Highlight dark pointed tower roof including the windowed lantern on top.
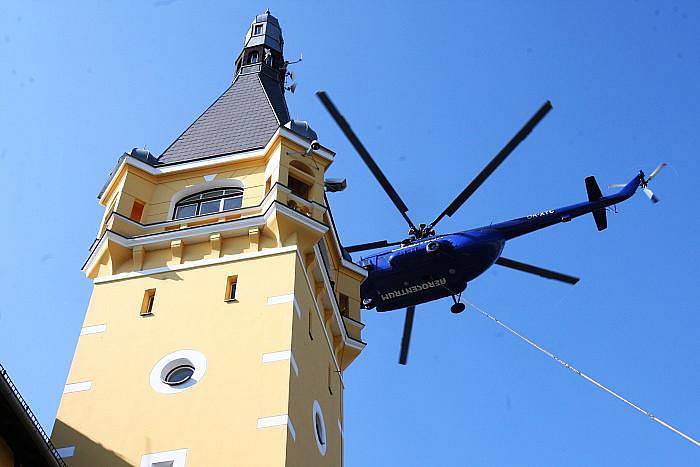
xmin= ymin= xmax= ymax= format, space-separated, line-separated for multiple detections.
xmin=158 ymin=10 xmax=290 ymax=164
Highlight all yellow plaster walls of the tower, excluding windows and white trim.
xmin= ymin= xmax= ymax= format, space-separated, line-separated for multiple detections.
xmin=59 ymin=133 xmax=362 ymax=467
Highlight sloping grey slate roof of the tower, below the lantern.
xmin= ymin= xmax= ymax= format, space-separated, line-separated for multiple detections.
xmin=158 ymin=73 xmax=290 ymax=164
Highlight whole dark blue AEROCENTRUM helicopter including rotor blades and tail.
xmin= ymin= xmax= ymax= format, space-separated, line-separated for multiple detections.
xmin=316 ymin=91 xmax=667 ymax=365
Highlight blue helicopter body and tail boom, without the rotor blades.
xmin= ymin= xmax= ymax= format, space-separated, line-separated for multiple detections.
xmin=360 ymin=174 xmax=644 ymax=311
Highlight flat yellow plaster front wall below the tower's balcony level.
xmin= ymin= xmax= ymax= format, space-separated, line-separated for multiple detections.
xmin=52 ymin=251 xmax=296 ymax=467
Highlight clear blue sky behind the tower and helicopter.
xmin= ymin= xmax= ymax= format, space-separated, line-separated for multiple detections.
xmin=0 ymin=0 xmax=700 ymax=467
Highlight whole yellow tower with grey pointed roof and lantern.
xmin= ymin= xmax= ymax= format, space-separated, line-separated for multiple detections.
xmin=52 ymin=12 xmax=366 ymax=467
